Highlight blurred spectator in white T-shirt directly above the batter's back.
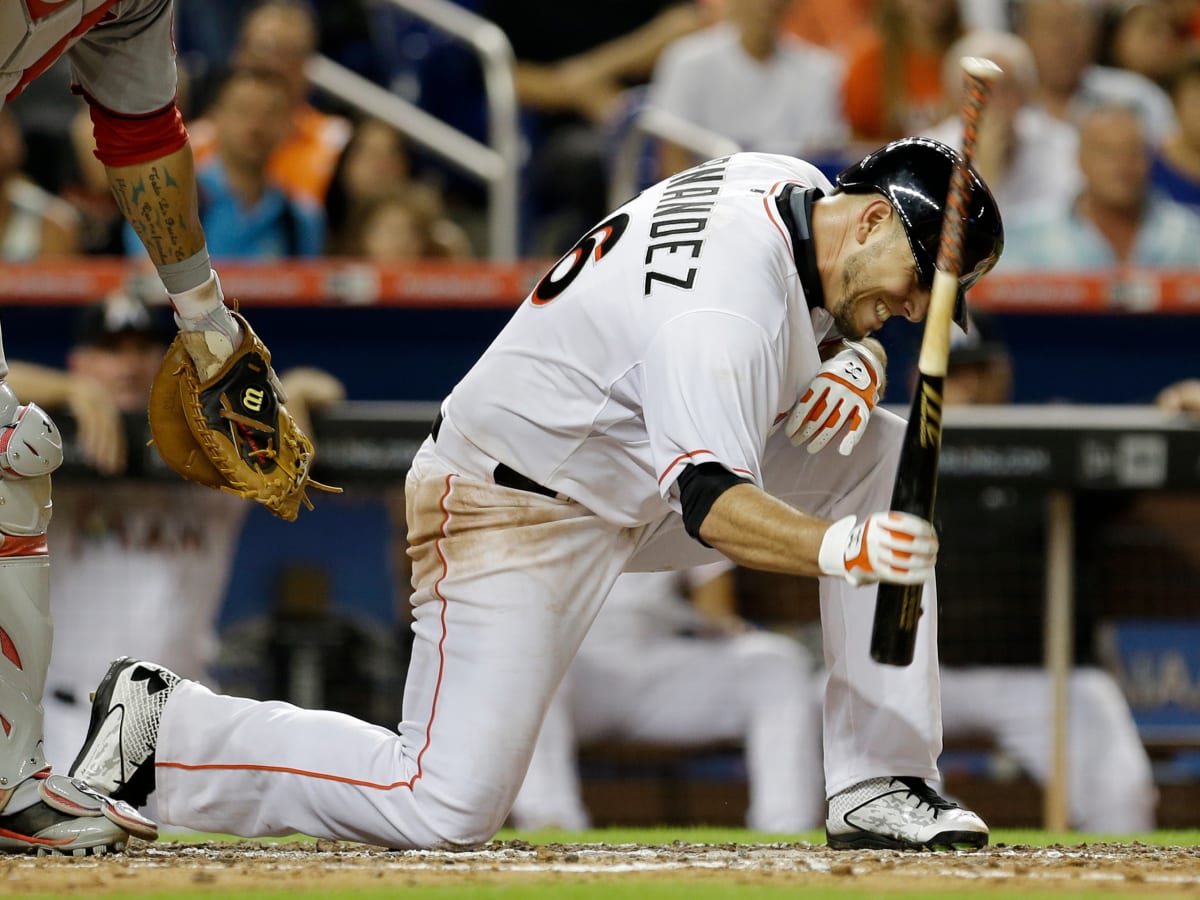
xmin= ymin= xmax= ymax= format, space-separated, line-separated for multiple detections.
xmin=647 ymin=0 xmax=848 ymax=176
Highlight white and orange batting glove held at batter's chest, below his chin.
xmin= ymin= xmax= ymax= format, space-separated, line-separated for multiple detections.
xmin=784 ymin=341 xmax=883 ymax=456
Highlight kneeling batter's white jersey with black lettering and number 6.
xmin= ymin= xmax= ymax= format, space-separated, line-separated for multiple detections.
xmin=444 ymin=154 xmax=832 ymax=526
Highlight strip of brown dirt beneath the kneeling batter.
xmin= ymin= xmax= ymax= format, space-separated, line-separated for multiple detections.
xmin=0 ymin=841 xmax=1200 ymax=895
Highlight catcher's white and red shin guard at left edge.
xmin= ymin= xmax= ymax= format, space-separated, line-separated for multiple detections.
xmin=0 ymin=383 xmax=62 ymax=810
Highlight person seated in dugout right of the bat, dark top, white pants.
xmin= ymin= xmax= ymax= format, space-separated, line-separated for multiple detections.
xmin=937 ymin=311 xmax=1157 ymax=834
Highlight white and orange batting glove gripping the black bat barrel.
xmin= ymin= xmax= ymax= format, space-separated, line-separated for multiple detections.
xmin=817 ymin=511 xmax=937 ymax=584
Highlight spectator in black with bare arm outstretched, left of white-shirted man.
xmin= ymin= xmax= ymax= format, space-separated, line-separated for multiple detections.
xmin=480 ymin=0 xmax=713 ymax=257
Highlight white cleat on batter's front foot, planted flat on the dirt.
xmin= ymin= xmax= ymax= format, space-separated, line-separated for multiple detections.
xmin=826 ymin=775 xmax=988 ymax=850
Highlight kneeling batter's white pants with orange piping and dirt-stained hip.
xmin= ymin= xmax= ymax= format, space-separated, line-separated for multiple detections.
xmin=156 ymin=410 xmax=941 ymax=847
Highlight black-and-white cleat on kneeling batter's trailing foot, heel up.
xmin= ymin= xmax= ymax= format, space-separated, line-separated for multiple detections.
xmin=71 ymin=656 xmax=180 ymax=806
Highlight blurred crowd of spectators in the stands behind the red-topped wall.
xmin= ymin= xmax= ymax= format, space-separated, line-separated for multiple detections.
xmin=11 ymin=0 xmax=1200 ymax=271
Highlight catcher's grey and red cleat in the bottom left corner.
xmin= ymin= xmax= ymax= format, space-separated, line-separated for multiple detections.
xmin=0 ymin=770 xmax=158 ymax=857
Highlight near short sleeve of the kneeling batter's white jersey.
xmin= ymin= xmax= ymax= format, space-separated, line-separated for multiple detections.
xmin=643 ymin=311 xmax=781 ymax=497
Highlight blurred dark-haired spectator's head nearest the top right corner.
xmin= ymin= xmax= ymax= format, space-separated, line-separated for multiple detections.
xmin=1097 ymin=0 xmax=1187 ymax=90
